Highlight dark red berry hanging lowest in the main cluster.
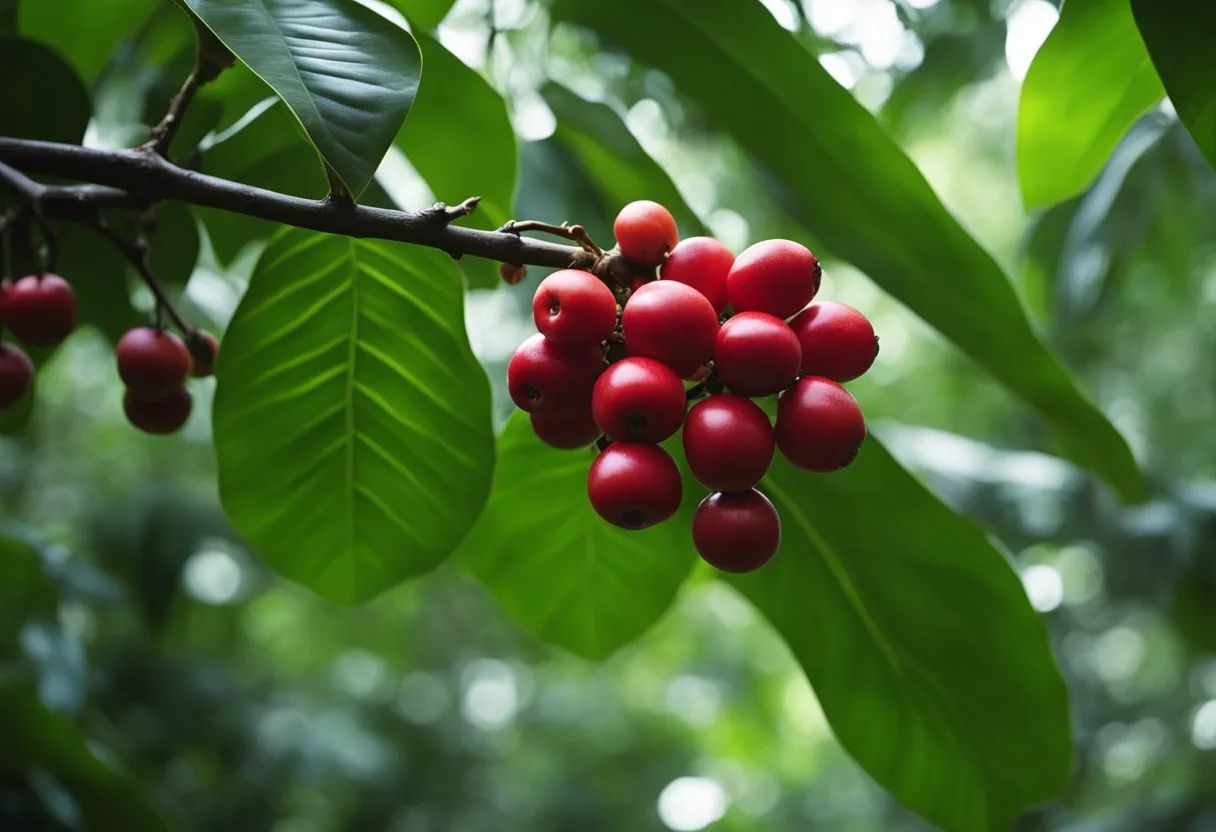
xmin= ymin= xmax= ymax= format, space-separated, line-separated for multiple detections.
xmin=692 ymin=490 xmax=781 ymax=573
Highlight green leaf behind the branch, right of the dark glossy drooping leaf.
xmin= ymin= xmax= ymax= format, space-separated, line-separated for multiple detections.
xmin=396 ymin=34 xmax=519 ymax=287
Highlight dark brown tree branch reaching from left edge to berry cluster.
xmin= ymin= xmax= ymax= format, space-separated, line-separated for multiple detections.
xmin=0 ymin=137 xmax=605 ymax=274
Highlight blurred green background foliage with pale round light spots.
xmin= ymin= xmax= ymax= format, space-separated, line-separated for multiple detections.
xmin=0 ymin=0 xmax=1216 ymax=832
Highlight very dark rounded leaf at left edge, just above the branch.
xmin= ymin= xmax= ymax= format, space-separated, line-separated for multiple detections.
xmin=0 ymin=36 xmax=92 ymax=145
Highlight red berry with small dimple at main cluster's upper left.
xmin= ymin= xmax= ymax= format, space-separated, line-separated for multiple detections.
xmin=533 ymin=269 xmax=617 ymax=347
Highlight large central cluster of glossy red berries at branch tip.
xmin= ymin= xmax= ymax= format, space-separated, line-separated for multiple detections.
xmin=507 ymin=201 xmax=878 ymax=572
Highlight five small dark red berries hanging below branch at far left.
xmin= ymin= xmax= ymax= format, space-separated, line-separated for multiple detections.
xmin=0 ymin=274 xmax=219 ymax=434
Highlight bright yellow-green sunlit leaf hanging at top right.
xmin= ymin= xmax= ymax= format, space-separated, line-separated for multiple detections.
xmin=1018 ymin=0 xmax=1165 ymax=210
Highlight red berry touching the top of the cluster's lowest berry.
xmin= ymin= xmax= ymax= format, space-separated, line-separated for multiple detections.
xmin=683 ymin=393 xmax=773 ymax=491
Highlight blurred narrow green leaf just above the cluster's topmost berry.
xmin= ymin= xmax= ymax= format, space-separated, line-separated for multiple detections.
xmin=541 ymin=83 xmax=705 ymax=237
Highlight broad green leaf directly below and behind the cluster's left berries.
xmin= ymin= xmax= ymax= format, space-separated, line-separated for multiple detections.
xmin=460 ymin=412 xmax=699 ymax=659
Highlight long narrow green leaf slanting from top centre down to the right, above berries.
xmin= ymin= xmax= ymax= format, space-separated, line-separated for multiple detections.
xmin=553 ymin=0 xmax=1143 ymax=499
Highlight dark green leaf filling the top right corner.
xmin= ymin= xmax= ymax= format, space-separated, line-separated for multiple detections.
xmin=1131 ymin=0 xmax=1216 ymax=168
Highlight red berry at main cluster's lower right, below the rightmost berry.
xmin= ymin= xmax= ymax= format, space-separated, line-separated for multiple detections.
xmin=773 ymin=376 xmax=866 ymax=472
